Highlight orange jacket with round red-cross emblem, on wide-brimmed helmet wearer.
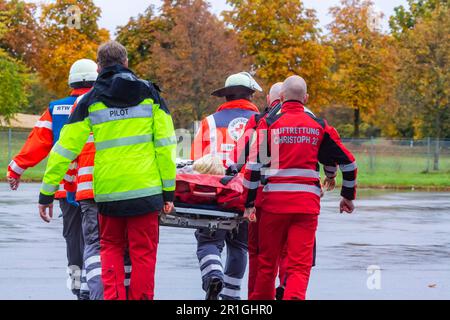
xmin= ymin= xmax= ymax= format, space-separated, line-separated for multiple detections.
xmin=191 ymin=99 xmax=259 ymax=167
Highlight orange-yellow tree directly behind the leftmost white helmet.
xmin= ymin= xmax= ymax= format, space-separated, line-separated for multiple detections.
xmin=39 ymin=0 xmax=109 ymax=96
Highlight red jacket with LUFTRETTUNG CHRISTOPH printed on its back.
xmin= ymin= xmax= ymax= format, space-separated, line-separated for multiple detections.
xmin=244 ymin=101 xmax=357 ymax=214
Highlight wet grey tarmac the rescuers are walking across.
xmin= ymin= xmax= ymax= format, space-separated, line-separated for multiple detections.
xmin=0 ymin=184 xmax=450 ymax=299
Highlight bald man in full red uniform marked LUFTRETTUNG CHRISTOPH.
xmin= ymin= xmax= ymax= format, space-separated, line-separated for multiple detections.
xmin=244 ymin=76 xmax=357 ymax=300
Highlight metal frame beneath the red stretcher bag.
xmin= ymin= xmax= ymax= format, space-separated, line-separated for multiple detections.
xmin=159 ymin=207 xmax=243 ymax=232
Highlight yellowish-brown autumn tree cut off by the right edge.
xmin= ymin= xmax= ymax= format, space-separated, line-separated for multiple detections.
xmin=397 ymin=5 xmax=450 ymax=170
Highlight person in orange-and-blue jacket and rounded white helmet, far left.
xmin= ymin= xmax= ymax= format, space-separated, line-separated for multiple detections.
xmin=7 ymin=59 xmax=97 ymax=298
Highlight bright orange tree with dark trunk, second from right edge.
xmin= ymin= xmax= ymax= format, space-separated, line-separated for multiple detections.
xmin=329 ymin=0 xmax=395 ymax=137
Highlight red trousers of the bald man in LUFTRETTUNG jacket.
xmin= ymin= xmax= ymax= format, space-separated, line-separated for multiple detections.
xmin=249 ymin=211 xmax=318 ymax=300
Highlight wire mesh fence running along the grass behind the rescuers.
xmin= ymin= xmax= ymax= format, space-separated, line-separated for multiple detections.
xmin=0 ymin=128 xmax=450 ymax=182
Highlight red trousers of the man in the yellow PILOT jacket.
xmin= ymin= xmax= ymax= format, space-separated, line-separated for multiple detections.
xmin=99 ymin=212 xmax=159 ymax=300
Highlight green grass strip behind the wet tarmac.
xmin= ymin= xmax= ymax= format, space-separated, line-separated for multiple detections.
xmin=0 ymin=131 xmax=450 ymax=190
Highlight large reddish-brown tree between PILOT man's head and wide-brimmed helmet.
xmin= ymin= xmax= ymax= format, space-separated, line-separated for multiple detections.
xmin=118 ymin=0 xmax=243 ymax=127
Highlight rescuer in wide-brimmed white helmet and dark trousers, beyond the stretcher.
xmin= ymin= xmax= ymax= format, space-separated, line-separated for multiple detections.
xmin=192 ymin=72 xmax=262 ymax=300
